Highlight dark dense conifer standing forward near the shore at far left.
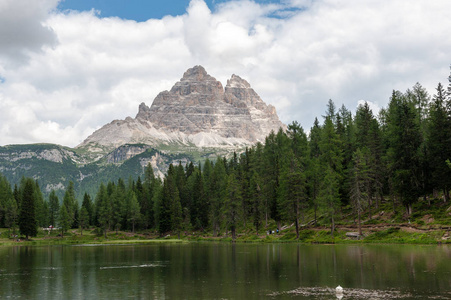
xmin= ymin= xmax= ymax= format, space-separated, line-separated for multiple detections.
xmin=19 ymin=178 xmax=38 ymax=240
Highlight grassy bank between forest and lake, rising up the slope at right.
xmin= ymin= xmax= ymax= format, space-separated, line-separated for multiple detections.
xmin=0 ymin=199 xmax=451 ymax=246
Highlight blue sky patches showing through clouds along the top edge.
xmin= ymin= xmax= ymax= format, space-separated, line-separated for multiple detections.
xmin=58 ymin=0 xmax=280 ymax=22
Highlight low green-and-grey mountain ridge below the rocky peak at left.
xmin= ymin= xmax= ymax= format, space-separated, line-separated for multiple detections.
xmin=0 ymin=144 xmax=191 ymax=199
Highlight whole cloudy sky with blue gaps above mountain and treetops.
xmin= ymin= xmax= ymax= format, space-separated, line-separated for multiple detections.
xmin=0 ymin=0 xmax=451 ymax=146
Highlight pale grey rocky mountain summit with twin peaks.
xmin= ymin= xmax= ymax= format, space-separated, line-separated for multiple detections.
xmin=77 ymin=66 xmax=285 ymax=154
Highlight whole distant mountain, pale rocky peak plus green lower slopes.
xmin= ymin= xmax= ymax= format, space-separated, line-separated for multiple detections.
xmin=0 ymin=66 xmax=286 ymax=198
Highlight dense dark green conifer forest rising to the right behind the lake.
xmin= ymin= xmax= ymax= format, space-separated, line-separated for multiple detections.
xmin=0 ymin=71 xmax=451 ymax=238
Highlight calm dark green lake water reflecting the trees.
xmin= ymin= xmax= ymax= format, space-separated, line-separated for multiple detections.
xmin=0 ymin=243 xmax=451 ymax=299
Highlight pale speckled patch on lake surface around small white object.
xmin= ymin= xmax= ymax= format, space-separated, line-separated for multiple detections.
xmin=268 ymin=287 xmax=420 ymax=300
